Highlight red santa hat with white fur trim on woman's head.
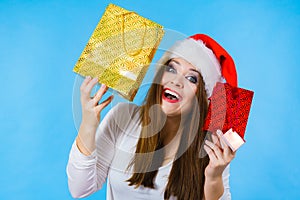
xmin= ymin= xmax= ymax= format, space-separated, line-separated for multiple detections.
xmin=158 ymin=34 xmax=237 ymax=97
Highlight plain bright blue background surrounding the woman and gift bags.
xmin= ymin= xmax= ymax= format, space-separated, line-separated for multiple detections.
xmin=0 ymin=0 xmax=300 ymax=200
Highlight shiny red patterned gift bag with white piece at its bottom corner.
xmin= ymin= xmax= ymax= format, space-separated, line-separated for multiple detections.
xmin=203 ymin=83 xmax=254 ymax=151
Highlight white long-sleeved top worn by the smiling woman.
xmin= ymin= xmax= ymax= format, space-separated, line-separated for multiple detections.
xmin=66 ymin=103 xmax=231 ymax=200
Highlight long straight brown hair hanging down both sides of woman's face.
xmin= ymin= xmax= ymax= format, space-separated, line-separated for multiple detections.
xmin=127 ymin=63 xmax=209 ymax=200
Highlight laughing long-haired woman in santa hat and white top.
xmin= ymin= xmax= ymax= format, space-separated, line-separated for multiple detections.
xmin=67 ymin=34 xmax=236 ymax=200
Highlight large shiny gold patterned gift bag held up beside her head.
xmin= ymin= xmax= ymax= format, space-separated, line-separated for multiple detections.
xmin=73 ymin=4 xmax=164 ymax=101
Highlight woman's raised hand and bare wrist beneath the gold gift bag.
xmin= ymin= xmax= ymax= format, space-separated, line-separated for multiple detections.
xmin=76 ymin=76 xmax=113 ymax=155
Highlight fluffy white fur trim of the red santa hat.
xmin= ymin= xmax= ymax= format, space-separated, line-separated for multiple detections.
xmin=158 ymin=38 xmax=222 ymax=97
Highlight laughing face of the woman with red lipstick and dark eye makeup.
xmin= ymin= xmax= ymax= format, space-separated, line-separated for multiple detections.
xmin=161 ymin=58 xmax=200 ymax=116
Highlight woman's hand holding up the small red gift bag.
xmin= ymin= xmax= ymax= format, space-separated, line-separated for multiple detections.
xmin=204 ymin=130 xmax=235 ymax=179
